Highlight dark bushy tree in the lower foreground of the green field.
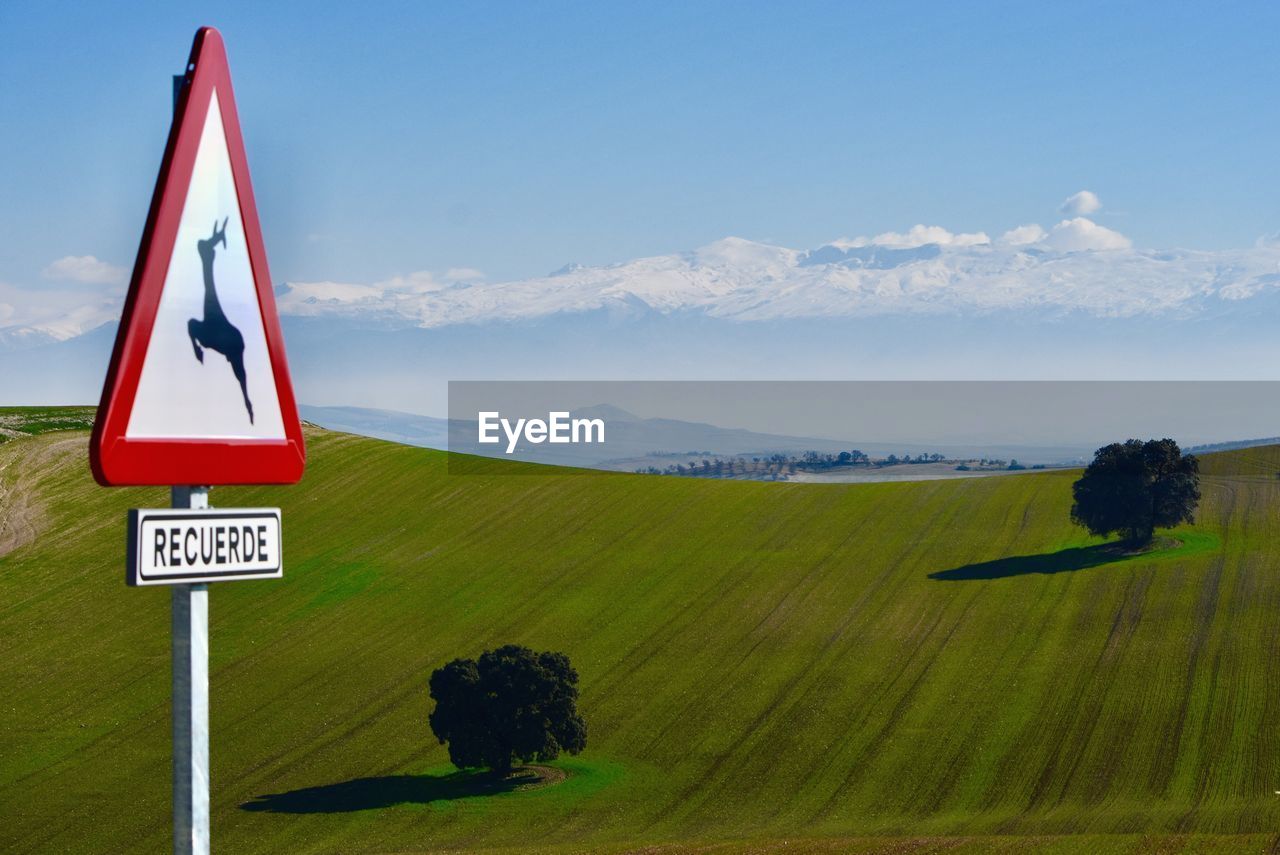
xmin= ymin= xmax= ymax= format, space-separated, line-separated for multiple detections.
xmin=430 ymin=644 xmax=586 ymax=774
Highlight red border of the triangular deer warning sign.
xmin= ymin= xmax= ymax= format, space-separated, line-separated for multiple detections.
xmin=90 ymin=27 xmax=306 ymax=486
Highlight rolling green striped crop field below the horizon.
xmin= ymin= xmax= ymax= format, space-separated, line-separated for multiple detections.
xmin=0 ymin=409 xmax=1280 ymax=852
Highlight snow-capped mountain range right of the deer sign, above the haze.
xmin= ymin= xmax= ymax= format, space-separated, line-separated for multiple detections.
xmin=280 ymin=218 xmax=1280 ymax=328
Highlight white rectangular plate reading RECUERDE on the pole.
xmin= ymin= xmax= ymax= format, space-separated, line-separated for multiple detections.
xmin=127 ymin=508 xmax=283 ymax=585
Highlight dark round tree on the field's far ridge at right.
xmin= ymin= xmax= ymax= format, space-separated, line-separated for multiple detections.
xmin=1071 ymin=439 xmax=1199 ymax=545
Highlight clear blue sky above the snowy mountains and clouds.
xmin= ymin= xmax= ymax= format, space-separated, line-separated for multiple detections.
xmin=0 ymin=3 xmax=1280 ymax=285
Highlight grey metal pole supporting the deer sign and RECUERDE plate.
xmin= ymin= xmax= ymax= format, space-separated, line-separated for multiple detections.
xmin=172 ymin=486 xmax=209 ymax=855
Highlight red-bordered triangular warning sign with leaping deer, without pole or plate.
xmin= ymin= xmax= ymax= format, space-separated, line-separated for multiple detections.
xmin=90 ymin=27 xmax=306 ymax=485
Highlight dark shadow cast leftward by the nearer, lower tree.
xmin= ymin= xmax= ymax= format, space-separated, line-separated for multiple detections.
xmin=241 ymin=769 xmax=541 ymax=814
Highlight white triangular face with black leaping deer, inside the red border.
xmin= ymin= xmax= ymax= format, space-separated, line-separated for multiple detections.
xmin=125 ymin=92 xmax=284 ymax=439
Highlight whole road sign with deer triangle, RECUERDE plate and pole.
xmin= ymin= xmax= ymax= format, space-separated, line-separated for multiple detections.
xmin=90 ymin=27 xmax=306 ymax=855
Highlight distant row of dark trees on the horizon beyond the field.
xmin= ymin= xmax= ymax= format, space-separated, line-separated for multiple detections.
xmin=636 ymin=448 xmax=1038 ymax=480
